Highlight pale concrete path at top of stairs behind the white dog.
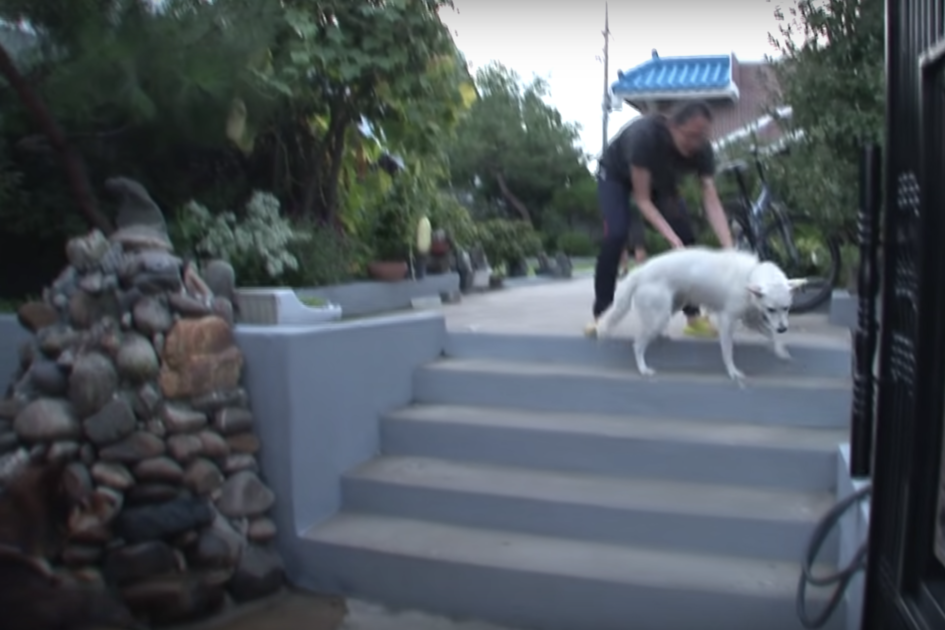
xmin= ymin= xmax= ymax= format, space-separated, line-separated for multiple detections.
xmin=443 ymin=277 xmax=850 ymax=348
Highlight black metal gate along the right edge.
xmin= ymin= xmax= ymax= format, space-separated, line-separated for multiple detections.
xmin=863 ymin=0 xmax=945 ymax=630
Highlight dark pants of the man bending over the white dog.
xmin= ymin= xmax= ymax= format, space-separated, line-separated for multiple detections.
xmin=594 ymin=176 xmax=699 ymax=318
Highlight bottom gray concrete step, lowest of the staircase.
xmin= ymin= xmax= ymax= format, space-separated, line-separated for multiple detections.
xmin=301 ymin=512 xmax=844 ymax=630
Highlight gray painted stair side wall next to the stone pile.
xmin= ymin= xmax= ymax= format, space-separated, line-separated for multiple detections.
xmin=236 ymin=312 xmax=446 ymax=581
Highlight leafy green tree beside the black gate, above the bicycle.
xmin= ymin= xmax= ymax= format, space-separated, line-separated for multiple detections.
xmin=770 ymin=0 xmax=885 ymax=228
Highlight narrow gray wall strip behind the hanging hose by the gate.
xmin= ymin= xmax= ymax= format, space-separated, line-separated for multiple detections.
xmin=837 ymin=444 xmax=870 ymax=630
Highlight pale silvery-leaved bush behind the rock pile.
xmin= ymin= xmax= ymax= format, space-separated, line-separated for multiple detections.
xmin=168 ymin=191 xmax=311 ymax=282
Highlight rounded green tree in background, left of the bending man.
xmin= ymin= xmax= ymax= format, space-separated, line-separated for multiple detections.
xmin=449 ymin=64 xmax=588 ymax=229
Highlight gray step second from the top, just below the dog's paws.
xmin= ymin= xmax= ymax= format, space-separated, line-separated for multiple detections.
xmin=414 ymin=359 xmax=851 ymax=428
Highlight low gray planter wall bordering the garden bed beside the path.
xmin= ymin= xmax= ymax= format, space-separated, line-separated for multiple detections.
xmin=295 ymin=273 xmax=459 ymax=317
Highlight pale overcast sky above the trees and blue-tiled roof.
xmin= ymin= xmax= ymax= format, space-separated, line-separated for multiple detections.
xmin=442 ymin=0 xmax=791 ymax=154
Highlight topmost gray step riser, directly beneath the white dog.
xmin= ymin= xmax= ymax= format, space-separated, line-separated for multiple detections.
xmin=445 ymin=332 xmax=851 ymax=378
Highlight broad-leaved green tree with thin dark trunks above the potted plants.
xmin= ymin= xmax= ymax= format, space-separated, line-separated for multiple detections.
xmin=253 ymin=0 xmax=467 ymax=221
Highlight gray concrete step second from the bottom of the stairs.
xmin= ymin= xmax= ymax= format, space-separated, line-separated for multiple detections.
xmin=342 ymin=457 xmax=837 ymax=562
